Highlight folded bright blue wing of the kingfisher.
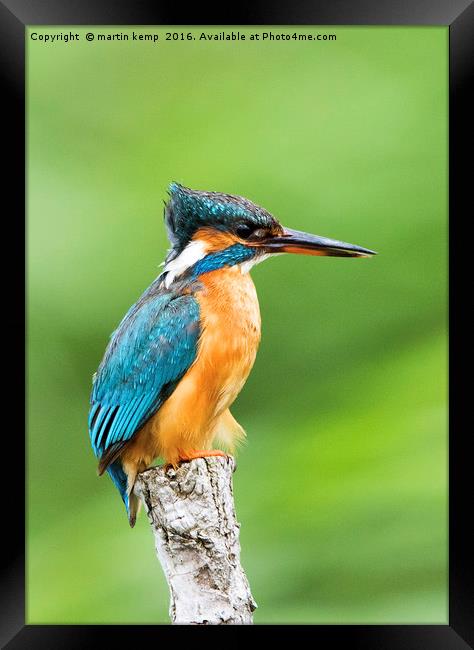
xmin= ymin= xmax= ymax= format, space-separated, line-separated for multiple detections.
xmin=89 ymin=285 xmax=200 ymax=473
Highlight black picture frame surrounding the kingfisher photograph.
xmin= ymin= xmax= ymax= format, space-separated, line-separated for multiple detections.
xmin=0 ymin=0 xmax=474 ymax=650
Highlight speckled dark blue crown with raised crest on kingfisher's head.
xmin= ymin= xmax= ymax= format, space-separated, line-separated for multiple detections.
xmin=165 ymin=183 xmax=277 ymax=250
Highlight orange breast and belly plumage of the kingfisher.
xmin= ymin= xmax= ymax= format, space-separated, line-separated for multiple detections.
xmin=124 ymin=266 xmax=260 ymax=465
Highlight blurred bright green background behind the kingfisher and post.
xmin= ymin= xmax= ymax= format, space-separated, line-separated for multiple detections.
xmin=27 ymin=27 xmax=448 ymax=623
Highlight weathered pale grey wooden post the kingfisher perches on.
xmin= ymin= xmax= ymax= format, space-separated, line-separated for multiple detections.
xmin=135 ymin=456 xmax=257 ymax=625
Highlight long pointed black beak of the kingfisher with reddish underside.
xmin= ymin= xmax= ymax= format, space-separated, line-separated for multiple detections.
xmin=261 ymin=228 xmax=377 ymax=257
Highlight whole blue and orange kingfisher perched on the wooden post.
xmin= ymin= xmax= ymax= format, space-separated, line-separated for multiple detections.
xmin=89 ymin=183 xmax=375 ymax=528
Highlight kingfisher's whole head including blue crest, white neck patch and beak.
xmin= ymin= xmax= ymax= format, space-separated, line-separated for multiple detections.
xmin=161 ymin=183 xmax=375 ymax=284
